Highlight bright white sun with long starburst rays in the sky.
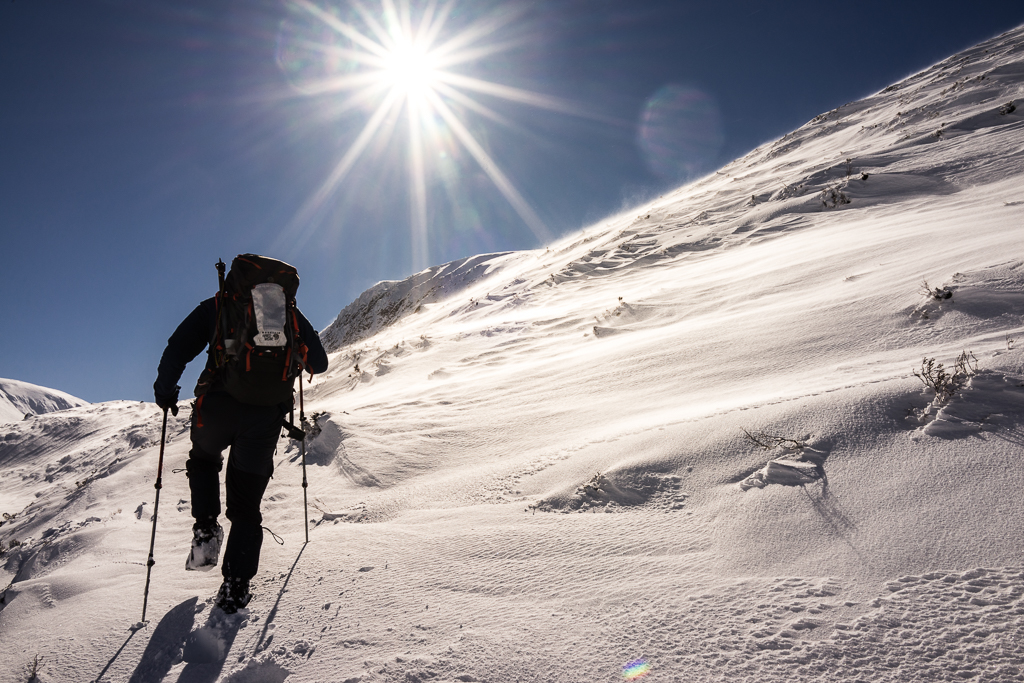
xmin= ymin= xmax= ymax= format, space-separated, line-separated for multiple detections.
xmin=275 ymin=0 xmax=591 ymax=269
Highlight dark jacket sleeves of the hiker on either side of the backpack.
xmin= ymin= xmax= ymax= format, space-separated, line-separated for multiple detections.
xmin=153 ymin=297 xmax=328 ymax=402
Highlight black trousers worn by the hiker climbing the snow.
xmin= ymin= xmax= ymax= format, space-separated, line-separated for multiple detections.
xmin=185 ymin=392 xmax=285 ymax=581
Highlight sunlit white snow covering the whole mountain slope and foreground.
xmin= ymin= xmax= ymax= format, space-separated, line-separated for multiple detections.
xmin=0 ymin=28 xmax=1024 ymax=683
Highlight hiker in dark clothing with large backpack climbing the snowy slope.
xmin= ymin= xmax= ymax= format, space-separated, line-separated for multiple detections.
xmin=154 ymin=254 xmax=328 ymax=613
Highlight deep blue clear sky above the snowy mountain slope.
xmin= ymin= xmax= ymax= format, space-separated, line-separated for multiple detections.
xmin=6 ymin=0 xmax=1024 ymax=401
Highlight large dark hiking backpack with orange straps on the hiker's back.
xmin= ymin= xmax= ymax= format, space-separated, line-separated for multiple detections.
xmin=200 ymin=254 xmax=306 ymax=405
